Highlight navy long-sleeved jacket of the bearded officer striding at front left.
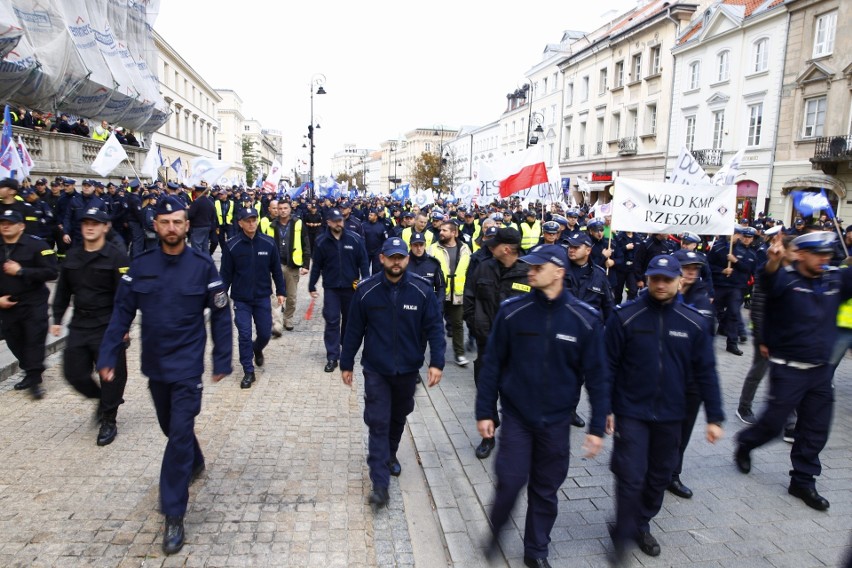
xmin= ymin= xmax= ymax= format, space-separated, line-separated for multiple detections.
xmin=98 ymin=247 xmax=233 ymax=383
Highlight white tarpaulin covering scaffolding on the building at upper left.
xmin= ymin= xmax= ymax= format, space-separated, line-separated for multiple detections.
xmin=0 ymin=0 xmax=168 ymax=132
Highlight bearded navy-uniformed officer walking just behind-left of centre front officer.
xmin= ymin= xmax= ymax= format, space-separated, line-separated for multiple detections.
xmin=308 ymin=208 xmax=370 ymax=373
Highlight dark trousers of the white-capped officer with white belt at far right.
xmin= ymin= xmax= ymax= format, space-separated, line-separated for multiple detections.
xmin=737 ymin=362 xmax=834 ymax=488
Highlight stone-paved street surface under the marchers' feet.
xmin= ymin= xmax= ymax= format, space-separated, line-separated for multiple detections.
xmin=0 ymin=272 xmax=852 ymax=568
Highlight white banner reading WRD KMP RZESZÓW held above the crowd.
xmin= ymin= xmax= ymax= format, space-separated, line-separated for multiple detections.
xmin=612 ymin=177 xmax=737 ymax=235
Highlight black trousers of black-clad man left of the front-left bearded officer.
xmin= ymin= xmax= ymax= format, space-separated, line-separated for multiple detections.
xmin=62 ymin=327 xmax=127 ymax=414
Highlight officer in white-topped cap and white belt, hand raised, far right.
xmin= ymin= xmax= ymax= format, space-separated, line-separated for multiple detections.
xmin=735 ymin=231 xmax=852 ymax=511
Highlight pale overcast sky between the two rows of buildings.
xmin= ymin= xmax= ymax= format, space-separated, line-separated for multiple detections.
xmin=154 ymin=0 xmax=636 ymax=175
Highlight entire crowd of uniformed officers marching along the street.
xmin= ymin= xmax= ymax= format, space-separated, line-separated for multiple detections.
xmin=0 ymin=178 xmax=852 ymax=566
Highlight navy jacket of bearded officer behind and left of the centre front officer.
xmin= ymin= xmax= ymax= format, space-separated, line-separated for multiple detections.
xmin=308 ymin=229 xmax=370 ymax=292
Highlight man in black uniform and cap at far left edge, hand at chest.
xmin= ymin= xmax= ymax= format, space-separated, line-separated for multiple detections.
xmin=0 ymin=209 xmax=57 ymax=399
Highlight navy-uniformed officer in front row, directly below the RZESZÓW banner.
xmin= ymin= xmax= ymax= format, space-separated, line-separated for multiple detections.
xmin=605 ymin=255 xmax=725 ymax=564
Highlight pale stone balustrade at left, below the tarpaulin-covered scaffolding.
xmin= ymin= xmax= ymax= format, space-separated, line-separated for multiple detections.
xmin=12 ymin=126 xmax=148 ymax=179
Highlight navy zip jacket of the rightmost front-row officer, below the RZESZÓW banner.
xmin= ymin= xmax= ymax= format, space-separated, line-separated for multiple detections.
xmin=606 ymin=293 xmax=725 ymax=423
